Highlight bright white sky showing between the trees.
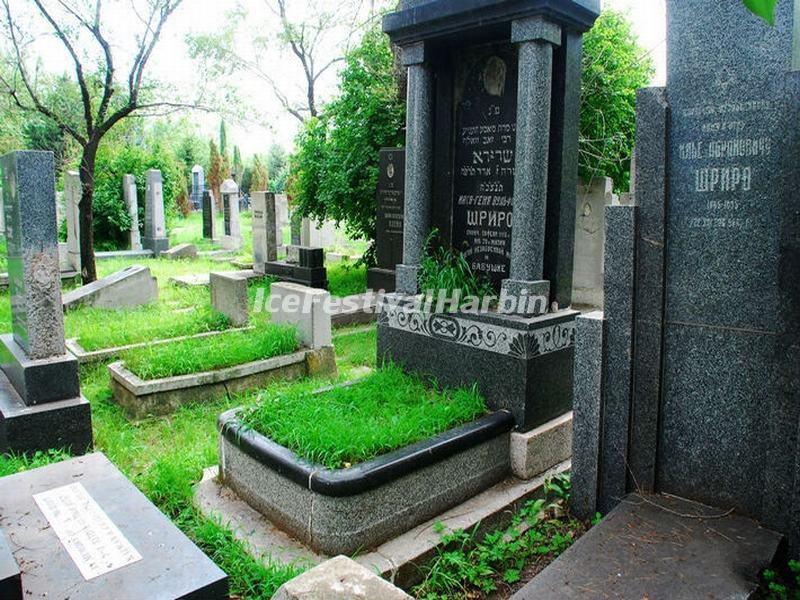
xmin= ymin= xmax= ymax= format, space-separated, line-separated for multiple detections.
xmin=25 ymin=0 xmax=666 ymax=155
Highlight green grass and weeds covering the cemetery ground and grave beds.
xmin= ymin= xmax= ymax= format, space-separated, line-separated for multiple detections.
xmin=0 ymin=235 xmax=583 ymax=598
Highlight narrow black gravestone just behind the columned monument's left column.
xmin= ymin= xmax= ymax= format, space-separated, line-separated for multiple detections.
xmin=367 ymin=148 xmax=406 ymax=292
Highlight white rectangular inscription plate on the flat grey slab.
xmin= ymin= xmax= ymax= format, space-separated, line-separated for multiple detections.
xmin=33 ymin=483 xmax=142 ymax=581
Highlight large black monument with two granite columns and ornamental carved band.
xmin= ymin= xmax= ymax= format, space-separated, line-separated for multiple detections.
xmin=378 ymin=0 xmax=600 ymax=431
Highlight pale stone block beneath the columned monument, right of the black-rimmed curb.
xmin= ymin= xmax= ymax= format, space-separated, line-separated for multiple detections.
xmin=511 ymin=412 xmax=572 ymax=479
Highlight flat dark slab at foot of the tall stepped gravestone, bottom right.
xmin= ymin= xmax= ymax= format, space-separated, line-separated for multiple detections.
xmin=512 ymin=494 xmax=781 ymax=600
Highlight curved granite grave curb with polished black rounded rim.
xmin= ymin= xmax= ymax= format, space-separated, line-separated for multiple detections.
xmin=218 ymin=384 xmax=514 ymax=555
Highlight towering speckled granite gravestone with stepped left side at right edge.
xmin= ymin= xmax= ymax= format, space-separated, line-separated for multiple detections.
xmin=573 ymin=0 xmax=800 ymax=554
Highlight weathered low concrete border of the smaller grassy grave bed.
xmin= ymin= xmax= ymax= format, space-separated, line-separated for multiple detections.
xmin=108 ymin=346 xmax=336 ymax=419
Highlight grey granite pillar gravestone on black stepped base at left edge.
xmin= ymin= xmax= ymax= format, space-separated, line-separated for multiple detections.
xmin=0 ymin=152 xmax=92 ymax=454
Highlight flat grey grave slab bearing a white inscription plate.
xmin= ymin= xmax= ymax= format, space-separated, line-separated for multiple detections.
xmin=0 ymin=454 xmax=229 ymax=600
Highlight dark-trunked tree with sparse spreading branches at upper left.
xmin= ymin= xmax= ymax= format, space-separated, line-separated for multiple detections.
xmin=0 ymin=0 xmax=192 ymax=283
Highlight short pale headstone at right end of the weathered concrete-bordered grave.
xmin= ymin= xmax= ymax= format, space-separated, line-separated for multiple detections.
xmin=270 ymin=282 xmax=333 ymax=348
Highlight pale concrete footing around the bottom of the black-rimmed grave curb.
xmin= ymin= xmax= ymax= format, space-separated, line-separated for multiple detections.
xmin=194 ymin=462 xmax=570 ymax=589
